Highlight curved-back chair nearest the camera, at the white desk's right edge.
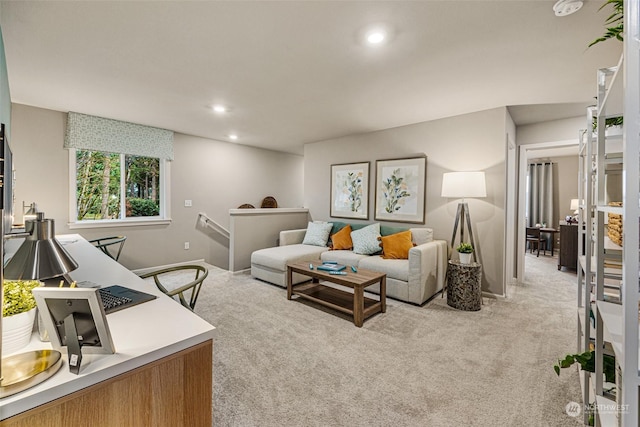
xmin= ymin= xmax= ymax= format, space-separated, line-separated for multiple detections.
xmin=140 ymin=265 xmax=209 ymax=311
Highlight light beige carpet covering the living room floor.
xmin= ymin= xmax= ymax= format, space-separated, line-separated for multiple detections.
xmin=180 ymin=256 xmax=581 ymax=426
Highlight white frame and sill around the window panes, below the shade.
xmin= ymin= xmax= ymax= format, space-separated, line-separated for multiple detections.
xmin=68 ymin=148 xmax=171 ymax=229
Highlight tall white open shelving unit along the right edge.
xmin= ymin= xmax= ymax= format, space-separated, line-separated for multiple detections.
xmin=578 ymin=1 xmax=640 ymax=426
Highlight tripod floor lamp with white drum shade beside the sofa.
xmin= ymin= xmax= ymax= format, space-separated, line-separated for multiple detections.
xmin=441 ymin=172 xmax=487 ymax=261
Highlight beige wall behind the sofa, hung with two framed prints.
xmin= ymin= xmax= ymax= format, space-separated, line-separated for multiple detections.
xmin=304 ymin=108 xmax=508 ymax=295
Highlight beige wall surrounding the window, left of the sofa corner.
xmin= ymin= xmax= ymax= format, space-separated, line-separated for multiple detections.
xmin=12 ymin=104 xmax=304 ymax=269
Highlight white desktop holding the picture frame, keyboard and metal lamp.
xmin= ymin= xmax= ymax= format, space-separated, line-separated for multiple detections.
xmin=0 ymin=234 xmax=215 ymax=420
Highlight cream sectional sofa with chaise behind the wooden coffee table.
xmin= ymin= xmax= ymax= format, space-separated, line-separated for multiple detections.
xmin=251 ymin=222 xmax=448 ymax=304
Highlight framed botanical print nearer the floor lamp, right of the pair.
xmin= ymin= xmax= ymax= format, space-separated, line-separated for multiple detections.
xmin=375 ymin=156 xmax=427 ymax=224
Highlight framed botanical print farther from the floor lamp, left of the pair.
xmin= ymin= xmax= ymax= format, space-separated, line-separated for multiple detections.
xmin=329 ymin=162 xmax=369 ymax=219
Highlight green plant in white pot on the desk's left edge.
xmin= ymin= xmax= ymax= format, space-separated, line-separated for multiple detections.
xmin=2 ymin=280 xmax=41 ymax=354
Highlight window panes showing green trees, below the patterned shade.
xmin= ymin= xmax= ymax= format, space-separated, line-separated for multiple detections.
xmin=70 ymin=149 xmax=167 ymax=223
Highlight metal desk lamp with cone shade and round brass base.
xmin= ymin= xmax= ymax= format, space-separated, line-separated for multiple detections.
xmin=0 ymin=211 xmax=78 ymax=398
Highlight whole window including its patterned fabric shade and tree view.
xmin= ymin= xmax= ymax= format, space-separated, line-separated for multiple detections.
xmin=64 ymin=111 xmax=173 ymax=228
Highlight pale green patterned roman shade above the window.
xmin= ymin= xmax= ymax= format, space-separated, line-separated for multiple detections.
xmin=64 ymin=112 xmax=173 ymax=160
